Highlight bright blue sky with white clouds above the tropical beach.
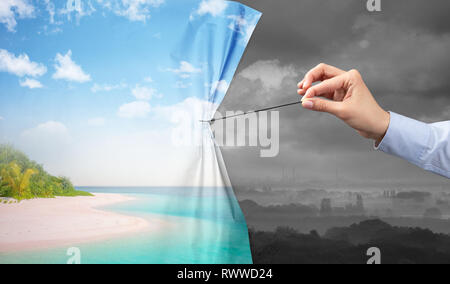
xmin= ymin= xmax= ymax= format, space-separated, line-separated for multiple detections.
xmin=0 ymin=0 xmax=260 ymax=186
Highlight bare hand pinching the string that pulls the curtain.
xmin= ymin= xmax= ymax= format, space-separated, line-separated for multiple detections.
xmin=298 ymin=64 xmax=390 ymax=145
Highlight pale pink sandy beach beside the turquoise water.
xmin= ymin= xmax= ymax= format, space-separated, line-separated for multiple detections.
xmin=0 ymin=194 xmax=155 ymax=253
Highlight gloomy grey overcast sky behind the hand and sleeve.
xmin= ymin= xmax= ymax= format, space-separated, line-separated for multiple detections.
xmin=220 ymin=0 xmax=450 ymax=190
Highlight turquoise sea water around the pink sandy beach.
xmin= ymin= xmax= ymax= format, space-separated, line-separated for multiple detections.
xmin=0 ymin=187 xmax=252 ymax=264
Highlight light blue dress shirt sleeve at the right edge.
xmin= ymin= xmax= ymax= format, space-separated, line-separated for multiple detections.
xmin=377 ymin=112 xmax=450 ymax=178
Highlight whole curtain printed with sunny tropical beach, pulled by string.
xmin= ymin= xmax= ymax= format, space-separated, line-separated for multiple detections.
xmin=0 ymin=0 xmax=261 ymax=263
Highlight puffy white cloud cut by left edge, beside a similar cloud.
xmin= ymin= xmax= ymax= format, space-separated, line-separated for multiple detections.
xmin=0 ymin=49 xmax=47 ymax=77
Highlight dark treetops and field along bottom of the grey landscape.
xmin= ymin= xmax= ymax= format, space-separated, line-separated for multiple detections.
xmin=250 ymin=220 xmax=450 ymax=264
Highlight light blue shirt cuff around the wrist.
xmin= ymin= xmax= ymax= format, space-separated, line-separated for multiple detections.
xmin=375 ymin=112 xmax=431 ymax=166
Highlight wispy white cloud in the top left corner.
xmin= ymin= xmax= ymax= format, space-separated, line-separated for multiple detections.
xmin=0 ymin=0 xmax=34 ymax=32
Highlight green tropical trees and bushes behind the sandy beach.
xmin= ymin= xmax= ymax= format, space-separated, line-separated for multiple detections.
xmin=0 ymin=144 xmax=91 ymax=200
